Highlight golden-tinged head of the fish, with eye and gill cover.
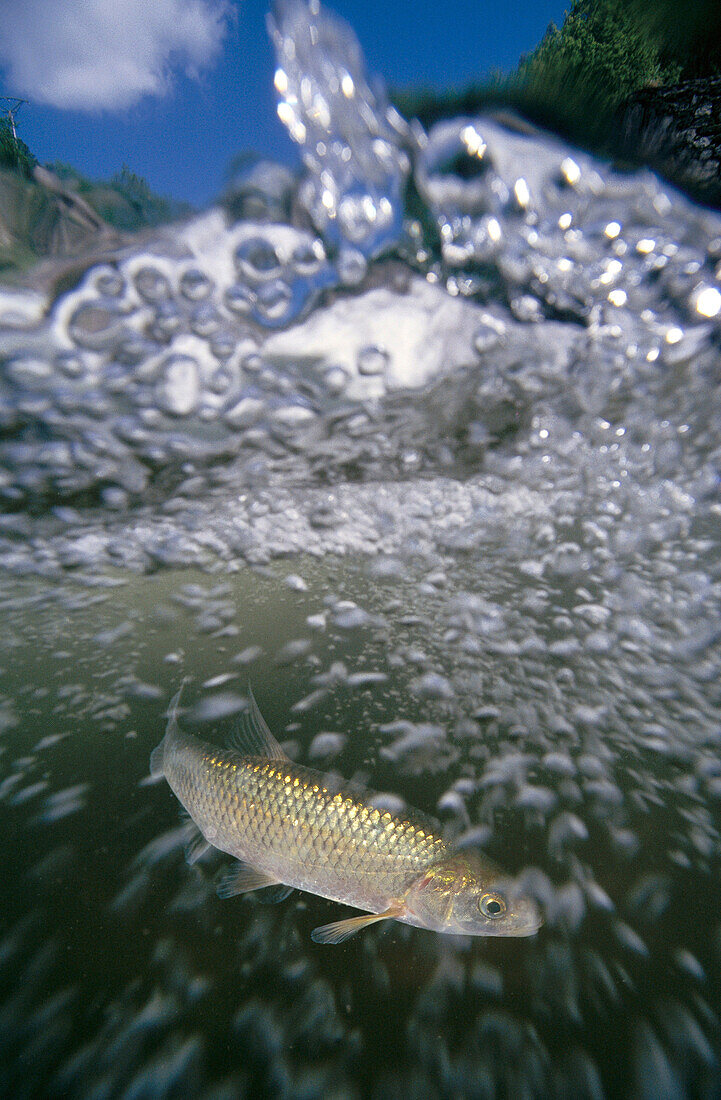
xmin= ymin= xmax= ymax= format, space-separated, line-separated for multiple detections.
xmin=403 ymin=851 xmax=543 ymax=936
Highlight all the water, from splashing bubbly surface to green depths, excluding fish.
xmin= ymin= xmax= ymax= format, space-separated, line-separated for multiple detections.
xmin=0 ymin=4 xmax=721 ymax=1098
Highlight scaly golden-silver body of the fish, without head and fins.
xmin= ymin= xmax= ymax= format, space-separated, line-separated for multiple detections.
xmin=169 ymin=734 xmax=448 ymax=909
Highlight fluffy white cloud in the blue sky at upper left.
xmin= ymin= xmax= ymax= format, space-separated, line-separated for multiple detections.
xmin=0 ymin=0 xmax=233 ymax=110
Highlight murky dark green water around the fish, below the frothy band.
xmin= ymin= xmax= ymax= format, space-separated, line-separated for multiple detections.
xmin=0 ymin=559 xmax=721 ymax=1097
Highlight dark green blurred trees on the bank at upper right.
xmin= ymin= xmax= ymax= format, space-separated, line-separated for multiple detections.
xmin=393 ymin=0 xmax=721 ymax=150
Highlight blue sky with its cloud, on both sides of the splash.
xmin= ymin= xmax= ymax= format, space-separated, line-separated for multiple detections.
xmin=0 ymin=0 xmax=570 ymax=206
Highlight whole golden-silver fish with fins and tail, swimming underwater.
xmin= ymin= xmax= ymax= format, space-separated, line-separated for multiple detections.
xmin=150 ymin=686 xmax=543 ymax=944
